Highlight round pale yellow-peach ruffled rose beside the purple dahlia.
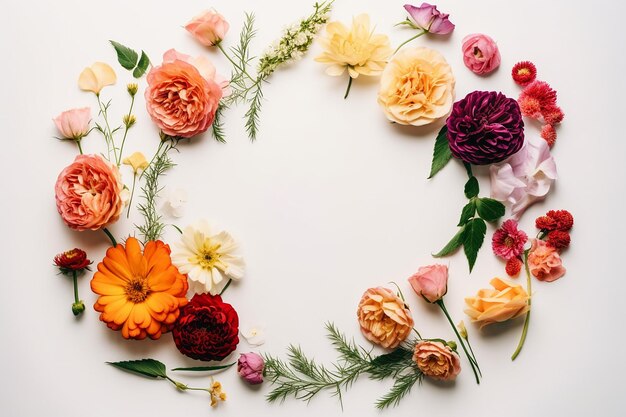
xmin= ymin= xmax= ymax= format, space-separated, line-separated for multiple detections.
xmin=378 ymin=47 xmax=455 ymax=126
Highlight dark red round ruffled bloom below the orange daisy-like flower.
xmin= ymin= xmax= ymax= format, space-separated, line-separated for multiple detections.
xmin=172 ymin=294 xmax=239 ymax=361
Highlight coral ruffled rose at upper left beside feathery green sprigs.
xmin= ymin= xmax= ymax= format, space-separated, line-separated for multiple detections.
xmin=145 ymin=49 xmax=226 ymax=138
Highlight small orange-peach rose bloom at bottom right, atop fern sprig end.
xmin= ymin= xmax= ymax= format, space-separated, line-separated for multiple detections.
xmin=413 ymin=340 xmax=461 ymax=381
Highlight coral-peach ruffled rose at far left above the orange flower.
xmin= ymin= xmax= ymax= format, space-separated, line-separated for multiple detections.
xmin=54 ymin=155 xmax=124 ymax=231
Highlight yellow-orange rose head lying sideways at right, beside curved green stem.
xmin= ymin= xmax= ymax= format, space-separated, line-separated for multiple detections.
xmin=465 ymin=278 xmax=529 ymax=328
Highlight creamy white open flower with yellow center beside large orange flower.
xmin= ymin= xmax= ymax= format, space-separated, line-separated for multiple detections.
xmin=172 ymin=220 xmax=245 ymax=295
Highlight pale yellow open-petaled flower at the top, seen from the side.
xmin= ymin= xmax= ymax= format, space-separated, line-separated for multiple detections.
xmin=315 ymin=14 xmax=392 ymax=78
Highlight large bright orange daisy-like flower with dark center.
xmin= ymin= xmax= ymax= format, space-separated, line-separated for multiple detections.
xmin=91 ymin=237 xmax=188 ymax=339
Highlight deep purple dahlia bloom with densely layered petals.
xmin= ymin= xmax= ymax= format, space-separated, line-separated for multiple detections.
xmin=446 ymin=91 xmax=524 ymax=165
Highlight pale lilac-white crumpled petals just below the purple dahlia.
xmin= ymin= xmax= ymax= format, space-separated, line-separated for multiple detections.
xmin=489 ymin=137 xmax=557 ymax=220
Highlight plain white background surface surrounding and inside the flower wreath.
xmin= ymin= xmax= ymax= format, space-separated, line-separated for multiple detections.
xmin=0 ymin=0 xmax=626 ymax=417
